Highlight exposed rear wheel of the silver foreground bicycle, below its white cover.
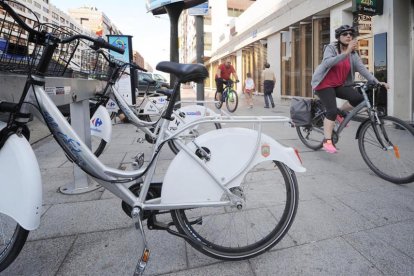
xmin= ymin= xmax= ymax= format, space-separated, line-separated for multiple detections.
xmin=171 ymin=161 xmax=299 ymax=261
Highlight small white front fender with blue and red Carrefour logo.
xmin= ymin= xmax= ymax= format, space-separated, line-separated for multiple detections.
xmin=90 ymin=105 xmax=112 ymax=143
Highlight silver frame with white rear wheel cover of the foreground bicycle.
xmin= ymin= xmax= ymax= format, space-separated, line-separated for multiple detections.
xmin=1 ymin=80 xmax=305 ymax=224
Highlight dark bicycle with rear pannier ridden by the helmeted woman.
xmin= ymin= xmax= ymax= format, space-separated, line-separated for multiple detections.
xmin=296 ymin=83 xmax=414 ymax=184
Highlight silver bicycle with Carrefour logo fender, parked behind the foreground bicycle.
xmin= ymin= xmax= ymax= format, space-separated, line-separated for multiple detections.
xmin=83 ymin=51 xmax=221 ymax=156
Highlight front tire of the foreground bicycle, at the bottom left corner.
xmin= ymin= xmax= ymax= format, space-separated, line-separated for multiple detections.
xmin=0 ymin=214 xmax=29 ymax=272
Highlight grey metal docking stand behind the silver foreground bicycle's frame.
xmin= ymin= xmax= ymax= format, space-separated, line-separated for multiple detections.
xmin=0 ymin=74 xmax=105 ymax=195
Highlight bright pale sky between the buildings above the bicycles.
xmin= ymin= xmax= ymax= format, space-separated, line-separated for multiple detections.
xmin=49 ymin=0 xmax=170 ymax=69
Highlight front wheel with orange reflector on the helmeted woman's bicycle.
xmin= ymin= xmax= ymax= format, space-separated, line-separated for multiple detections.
xmin=358 ymin=116 xmax=414 ymax=184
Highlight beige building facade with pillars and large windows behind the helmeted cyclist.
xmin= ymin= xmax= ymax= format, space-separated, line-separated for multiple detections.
xmin=180 ymin=0 xmax=414 ymax=120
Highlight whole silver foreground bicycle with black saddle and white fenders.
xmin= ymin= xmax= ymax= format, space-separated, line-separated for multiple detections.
xmin=0 ymin=0 xmax=305 ymax=275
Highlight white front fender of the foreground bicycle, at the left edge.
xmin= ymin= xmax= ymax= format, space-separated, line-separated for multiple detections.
xmin=0 ymin=134 xmax=42 ymax=231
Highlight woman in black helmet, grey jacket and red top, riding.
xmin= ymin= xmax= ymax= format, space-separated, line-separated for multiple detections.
xmin=311 ymin=25 xmax=388 ymax=153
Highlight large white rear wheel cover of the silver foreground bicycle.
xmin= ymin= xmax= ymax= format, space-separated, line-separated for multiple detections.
xmin=161 ymin=128 xmax=306 ymax=204
